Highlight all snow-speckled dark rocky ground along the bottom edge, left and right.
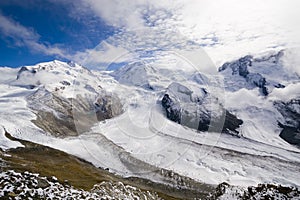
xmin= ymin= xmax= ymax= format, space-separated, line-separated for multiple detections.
xmin=0 ymin=170 xmax=300 ymax=200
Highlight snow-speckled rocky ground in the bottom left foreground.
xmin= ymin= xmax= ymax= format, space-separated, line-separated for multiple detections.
xmin=0 ymin=170 xmax=161 ymax=200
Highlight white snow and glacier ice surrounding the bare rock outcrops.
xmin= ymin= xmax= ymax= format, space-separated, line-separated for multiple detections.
xmin=0 ymin=50 xmax=300 ymax=191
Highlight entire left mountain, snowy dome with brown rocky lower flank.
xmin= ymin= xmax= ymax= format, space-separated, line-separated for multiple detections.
xmin=0 ymin=60 xmax=122 ymax=137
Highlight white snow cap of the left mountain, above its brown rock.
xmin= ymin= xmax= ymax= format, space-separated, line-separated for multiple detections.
xmin=10 ymin=60 xmax=101 ymax=98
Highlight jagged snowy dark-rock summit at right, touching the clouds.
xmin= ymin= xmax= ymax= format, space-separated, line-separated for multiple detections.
xmin=219 ymin=51 xmax=299 ymax=96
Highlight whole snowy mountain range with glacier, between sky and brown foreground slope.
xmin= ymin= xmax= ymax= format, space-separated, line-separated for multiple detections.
xmin=0 ymin=51 xmax=300 ymax=198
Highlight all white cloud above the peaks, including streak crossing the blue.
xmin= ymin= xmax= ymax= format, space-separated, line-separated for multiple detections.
xmin=0 ymin=0 xmax=300 ymax=70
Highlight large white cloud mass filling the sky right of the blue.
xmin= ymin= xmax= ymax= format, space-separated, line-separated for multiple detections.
xmin=75 ymin=0 xmax=300 ymax=68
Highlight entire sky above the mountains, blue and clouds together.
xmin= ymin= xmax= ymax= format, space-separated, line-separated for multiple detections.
xmin=0 ymin=0 xmax=300 ymax=69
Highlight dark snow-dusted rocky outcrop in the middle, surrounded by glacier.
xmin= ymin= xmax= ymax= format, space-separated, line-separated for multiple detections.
xmin=161 ymin=83 xmax=243 ymax=135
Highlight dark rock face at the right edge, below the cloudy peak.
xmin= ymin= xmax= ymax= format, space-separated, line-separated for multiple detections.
xmin=274 ymin=99 xmax=300 ymax=146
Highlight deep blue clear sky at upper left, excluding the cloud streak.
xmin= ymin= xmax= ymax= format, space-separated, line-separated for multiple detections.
xmin=0 ymin=0 xmax=114 ymax=67
